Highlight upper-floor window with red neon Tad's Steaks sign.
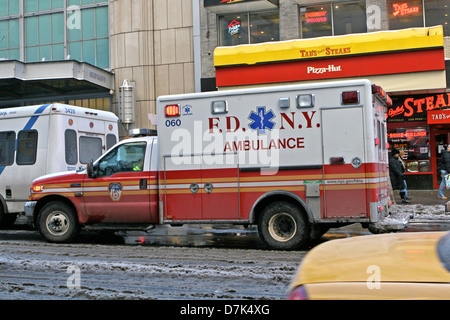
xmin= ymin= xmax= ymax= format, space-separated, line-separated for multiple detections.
xmin=387 ymin=0 xmax=423 ymax=30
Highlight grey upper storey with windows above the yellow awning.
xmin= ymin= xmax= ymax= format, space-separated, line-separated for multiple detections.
xmin=200 ymin=0 xmax=450 ymax=80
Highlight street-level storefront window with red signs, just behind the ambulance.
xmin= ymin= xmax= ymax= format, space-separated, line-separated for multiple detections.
xmin=388 ymin=127 xmax=431 ymax=172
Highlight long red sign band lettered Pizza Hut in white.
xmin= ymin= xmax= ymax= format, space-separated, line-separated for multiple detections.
xmin=216 ymin=48 xmax=445 ymax=87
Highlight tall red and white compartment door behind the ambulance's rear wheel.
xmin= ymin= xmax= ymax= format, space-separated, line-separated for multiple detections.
xmin=321 ymin=106 xmax=367 ymax=219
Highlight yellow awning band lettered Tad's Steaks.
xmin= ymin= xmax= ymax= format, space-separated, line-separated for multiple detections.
xmin=214 ymin=26 xmax=444 ymax=67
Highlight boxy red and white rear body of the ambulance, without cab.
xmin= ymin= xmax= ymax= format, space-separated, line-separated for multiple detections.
xmin=158 ymin=80 xmax=387 ymax=223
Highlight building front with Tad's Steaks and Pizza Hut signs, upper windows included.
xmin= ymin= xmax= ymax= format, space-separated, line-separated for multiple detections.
xmin=201 ymin=0 xmax=450 ymax=189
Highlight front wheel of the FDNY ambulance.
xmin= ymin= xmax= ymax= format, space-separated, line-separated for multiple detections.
xmin=37 ymin=201 xmax=80 ymax=243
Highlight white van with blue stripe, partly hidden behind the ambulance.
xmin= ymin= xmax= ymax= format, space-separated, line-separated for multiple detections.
xmin=0 ymin=103 xmax=118 ymax=226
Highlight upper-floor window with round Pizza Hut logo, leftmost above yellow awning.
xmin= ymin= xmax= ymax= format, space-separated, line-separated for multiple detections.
xmin=219 ymin=10 xmax=280 ymax=46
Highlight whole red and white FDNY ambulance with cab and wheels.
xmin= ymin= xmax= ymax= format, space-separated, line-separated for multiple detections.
xmin=26 ymin=80 xmax=407 ymax=249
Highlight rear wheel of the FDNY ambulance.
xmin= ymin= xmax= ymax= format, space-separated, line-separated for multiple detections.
xmin=258 ymin=201 xmax=309 ymax=250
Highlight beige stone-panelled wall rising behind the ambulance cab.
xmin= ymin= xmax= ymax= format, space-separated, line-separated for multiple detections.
xmin=110 ymin=0 xmax=194 ymax=128
